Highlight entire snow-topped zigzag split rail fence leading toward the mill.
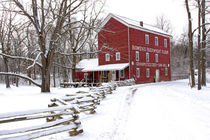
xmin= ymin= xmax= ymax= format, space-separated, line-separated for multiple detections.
xmin=0 ymin=79 xmax=135 ymax=140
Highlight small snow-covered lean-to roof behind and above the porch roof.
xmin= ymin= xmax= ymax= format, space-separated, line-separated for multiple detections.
xmin=76 ymin=58 xmax=98 ymax=69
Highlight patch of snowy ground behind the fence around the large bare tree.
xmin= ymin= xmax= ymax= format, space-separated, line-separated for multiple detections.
xmin=0 ymin=84 xmax=89 ymax=113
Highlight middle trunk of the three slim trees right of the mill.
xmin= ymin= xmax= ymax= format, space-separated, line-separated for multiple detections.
xmin=197 ymin=0 xmax=201 ymax=90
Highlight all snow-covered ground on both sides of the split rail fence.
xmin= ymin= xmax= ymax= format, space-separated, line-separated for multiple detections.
xmin=0 ymin=80 xmax=210 ymax=140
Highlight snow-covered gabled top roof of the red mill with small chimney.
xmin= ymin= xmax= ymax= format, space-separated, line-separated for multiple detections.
xmin=101 ymin=13 xmax=171 ymax=37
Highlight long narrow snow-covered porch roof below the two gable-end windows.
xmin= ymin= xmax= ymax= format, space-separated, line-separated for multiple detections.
xmin=82 ymin=63 xmax=129 ymax=72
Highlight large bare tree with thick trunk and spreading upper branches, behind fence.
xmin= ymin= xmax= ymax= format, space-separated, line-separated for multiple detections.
xmin=0 ymin=0 xmax=85 ymax=92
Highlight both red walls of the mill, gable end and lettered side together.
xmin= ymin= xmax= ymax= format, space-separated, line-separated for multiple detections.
xmin=76 ymin=18 xmax=171 ymax=83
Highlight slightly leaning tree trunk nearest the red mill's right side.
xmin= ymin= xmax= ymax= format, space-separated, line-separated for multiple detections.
xmin=185 ymin=0 xmax=195 ymax=88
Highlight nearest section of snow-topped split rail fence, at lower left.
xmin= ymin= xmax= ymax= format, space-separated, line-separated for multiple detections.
xmin=0 ymin=105 xmax=83 ymax=140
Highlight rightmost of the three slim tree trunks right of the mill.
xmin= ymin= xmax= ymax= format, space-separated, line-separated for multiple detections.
xmin=201 ymin=0 xmax=206 ymax=86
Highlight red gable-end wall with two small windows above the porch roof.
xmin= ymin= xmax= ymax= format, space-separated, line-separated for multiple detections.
xmin=98 ymin=18 xmax=129 ymax=65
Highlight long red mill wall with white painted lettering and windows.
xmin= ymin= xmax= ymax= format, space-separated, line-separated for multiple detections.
xmin=129 ymin=28 xmax=171 ymax=83
